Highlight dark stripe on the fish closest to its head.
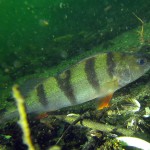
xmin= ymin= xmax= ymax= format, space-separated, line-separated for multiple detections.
xmin=107 ymin=52 xmax=116 ymax=77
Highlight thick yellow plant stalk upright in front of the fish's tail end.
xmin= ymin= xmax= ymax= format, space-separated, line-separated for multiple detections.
xmin=12 ymin=85 xmax=35 ymax=150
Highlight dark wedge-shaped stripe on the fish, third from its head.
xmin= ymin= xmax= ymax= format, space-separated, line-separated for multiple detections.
xmin=55 ymin=70 xmax=76 ymax=104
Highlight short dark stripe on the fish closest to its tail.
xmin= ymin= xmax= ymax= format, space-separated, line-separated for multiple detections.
xmin=36 ymin=84 xmax=48 ymax=107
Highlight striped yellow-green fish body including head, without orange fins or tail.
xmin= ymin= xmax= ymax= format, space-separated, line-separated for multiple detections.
xmin=25 ymin=52 xmax=150 ymax=112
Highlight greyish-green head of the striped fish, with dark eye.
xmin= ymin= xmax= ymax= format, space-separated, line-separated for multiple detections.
xmin=115 ymin=53 xmax=150 ymax=87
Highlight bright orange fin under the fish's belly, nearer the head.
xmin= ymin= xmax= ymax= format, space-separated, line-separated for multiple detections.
xmin=98 ymin=93 xmax=113 ymax=110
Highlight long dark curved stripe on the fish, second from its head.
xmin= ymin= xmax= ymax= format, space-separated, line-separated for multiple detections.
xmin=85 ymin=57 xmax=100 ymax=91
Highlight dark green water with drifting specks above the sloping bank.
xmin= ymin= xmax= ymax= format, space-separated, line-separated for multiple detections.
xmin=0 ymin=0 xmax=150 ymax=87
